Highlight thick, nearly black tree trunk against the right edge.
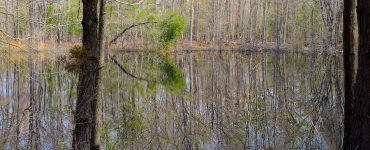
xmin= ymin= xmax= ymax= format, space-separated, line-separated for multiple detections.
xmin=344 ymin=0 xmax=370 ymax=150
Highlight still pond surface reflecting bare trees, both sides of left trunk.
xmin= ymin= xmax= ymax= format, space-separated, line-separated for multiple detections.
xmin=0 ymin=52 xmax=343 ymax=149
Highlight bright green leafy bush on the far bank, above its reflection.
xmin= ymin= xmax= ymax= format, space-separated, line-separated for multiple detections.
xmin=160 ymin=14 xmax=186 ymax=49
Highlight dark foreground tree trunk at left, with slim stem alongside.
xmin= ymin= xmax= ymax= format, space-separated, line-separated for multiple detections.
xmin=73 ymin=0 xmax=104 ymax=149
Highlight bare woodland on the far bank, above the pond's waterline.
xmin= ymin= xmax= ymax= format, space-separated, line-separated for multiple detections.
xmin=0 ymin=0 xmax=343 ymax=50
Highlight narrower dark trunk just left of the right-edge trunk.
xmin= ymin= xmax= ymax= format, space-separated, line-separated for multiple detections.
xmin=343 ymin=0 xmax=356 ymax=146
